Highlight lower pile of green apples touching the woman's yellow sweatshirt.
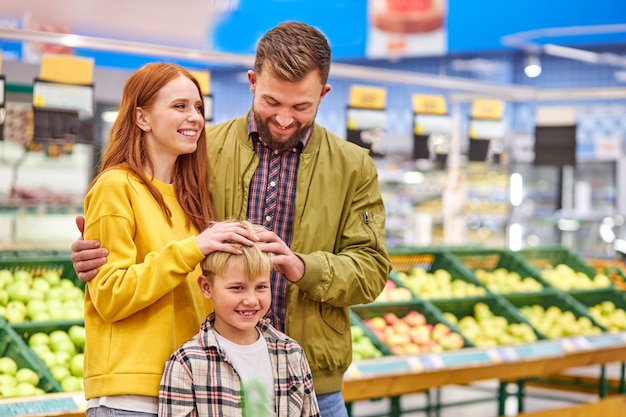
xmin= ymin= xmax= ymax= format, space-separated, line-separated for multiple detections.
xmin=24 ymin=325 xmax=85 ymax=392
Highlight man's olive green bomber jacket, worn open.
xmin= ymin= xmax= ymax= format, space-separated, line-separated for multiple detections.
xmin=207 ymin=116 xmax=391 ymax=394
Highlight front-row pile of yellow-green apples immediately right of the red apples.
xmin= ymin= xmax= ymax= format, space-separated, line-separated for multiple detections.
xmin=443 ymin=302 xmax=537 ymax=348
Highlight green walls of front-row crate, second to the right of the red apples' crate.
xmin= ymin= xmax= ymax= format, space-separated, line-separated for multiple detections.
xmin=503 ymin=289 xmax=607 ymax=337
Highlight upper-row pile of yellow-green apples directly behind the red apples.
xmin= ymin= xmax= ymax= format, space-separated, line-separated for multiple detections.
xmin=398 ymin=267 xmax=487 ymax=300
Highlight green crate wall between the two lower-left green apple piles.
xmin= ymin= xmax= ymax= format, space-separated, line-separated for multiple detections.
xmin=0 ymin=326 xmax=63 ymax=393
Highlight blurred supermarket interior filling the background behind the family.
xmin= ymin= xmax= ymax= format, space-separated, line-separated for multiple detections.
xmin=0 ymin=0 xmax=626 ymax=417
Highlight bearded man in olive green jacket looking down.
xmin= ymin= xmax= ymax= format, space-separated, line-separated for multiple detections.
xmin=72 ymin=22 xmax=391 ymax=417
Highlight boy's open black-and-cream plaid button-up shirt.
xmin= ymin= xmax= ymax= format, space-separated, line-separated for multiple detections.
xmin=159 ymin=313 xmax=319 ymax=417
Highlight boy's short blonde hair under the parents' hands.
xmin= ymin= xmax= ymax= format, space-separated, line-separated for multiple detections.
xmin=200 ymin=220 xmax=273 ymax=281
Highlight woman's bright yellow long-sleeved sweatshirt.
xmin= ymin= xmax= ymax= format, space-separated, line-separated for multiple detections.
xmin=84 ymin=169 xmax=212 ymax=399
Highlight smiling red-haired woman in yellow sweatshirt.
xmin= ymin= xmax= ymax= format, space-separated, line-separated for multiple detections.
xmin=84 ymin=63 xmax=254 ymax=417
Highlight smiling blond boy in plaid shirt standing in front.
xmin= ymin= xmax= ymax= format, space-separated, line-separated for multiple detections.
xmin=159 ymin=222 xmax=319 ymax=417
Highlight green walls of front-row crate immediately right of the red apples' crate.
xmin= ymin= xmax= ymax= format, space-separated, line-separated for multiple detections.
xmin=432 ymin=295 xmax=545 ymax=340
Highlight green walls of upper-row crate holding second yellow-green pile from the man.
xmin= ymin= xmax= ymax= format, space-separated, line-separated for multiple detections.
xmin=450 ymin=248 xmax=552 ymax=289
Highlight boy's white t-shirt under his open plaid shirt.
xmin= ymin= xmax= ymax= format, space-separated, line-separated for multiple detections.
xmin=216 ymin=332 xmax=275 ymax=417
